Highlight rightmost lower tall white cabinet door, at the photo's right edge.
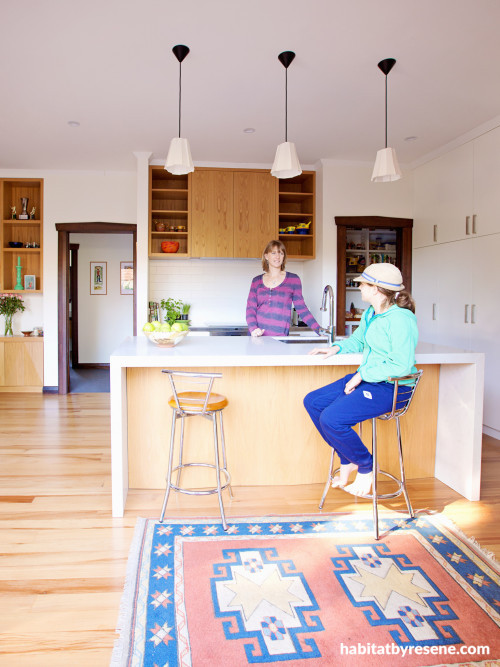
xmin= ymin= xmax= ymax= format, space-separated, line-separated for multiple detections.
xmin=466 ymin=234 xmax=500 ymax=431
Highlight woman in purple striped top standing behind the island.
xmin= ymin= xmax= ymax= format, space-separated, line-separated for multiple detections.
xmin=247 ymin=241 xmax=320 ymax=336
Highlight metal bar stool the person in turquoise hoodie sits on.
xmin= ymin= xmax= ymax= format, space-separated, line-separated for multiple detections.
xmin=319 ymin=371 xmax=423 ymax=540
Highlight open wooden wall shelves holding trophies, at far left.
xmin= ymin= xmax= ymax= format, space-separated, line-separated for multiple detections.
xmin=0 ymin=178 xmax=43 ymax=292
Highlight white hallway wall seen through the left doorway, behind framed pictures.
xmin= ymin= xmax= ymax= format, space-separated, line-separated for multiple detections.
xmin=70 ymin=234 xmax=133 ymax=364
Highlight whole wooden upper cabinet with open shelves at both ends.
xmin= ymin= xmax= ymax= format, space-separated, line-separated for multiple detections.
xmin=149 ymin=166 xmax=315 ymax=259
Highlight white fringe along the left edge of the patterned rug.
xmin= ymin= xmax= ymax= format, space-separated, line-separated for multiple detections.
xmin=110 ymin=518 xmax=147 ymax=667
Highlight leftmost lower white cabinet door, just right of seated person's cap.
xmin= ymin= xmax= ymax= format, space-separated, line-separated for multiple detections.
xmin=412 ymin=245 xmax=441 ymax=343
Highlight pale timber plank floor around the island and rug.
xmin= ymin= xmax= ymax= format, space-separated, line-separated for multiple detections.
xmin=0 ymin=394 xmax=500 ymax=667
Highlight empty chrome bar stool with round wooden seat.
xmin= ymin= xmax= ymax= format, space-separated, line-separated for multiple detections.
xmin=160 ymin=370 xmax=232 ymax=530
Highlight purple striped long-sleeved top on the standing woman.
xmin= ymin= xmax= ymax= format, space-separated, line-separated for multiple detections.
xmin=247 ymin=271 xmax=319 ymax=336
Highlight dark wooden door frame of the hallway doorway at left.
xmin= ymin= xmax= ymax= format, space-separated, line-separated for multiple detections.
xmin=56 ymin=222 xmax=137 ymax=394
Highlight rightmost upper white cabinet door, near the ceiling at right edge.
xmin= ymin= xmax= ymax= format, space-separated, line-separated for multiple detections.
xmin=474 ymin=127 xmax=500 ymax=236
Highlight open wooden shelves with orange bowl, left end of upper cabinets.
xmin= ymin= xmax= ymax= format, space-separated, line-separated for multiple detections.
xmin=149 ymin=165 xmax=191 ymax=259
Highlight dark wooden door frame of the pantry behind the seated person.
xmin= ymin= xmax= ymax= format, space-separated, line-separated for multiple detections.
xmin=335 ymin=215 xmax=413 ymax=335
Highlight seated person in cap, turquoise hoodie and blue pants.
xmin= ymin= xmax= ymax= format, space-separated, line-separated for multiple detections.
xmin=304 ymin=264 xmax=418 ymax=496
